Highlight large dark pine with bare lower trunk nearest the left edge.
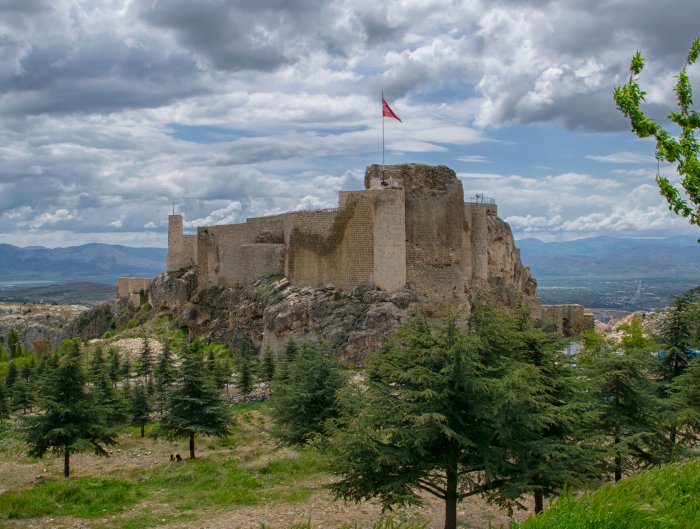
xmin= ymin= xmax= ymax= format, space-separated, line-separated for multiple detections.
xmin=24 ymin=349 xmax=116 ymax=477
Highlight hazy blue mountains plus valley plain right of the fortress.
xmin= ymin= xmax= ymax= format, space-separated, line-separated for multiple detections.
xmin=516 ymin=233 xmax=700 ymax=312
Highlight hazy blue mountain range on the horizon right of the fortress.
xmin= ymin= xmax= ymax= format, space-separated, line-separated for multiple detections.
xmin=516 ymin=231 xmax=700 ymax=276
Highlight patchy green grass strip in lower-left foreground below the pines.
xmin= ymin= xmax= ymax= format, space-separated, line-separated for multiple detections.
xmin=0 ymin=449 xmax=320 ymax=528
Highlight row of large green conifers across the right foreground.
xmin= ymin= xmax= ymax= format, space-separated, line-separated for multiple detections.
xmin=272 ymin=291 xmax=700 ymax=529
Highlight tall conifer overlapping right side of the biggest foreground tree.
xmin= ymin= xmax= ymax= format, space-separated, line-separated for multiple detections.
xmin=504 ymin=325 xmax=601 ymax=514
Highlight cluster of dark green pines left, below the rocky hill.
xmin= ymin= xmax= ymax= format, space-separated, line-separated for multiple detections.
xmin=0 ymin=340 xmax=231 ymax=477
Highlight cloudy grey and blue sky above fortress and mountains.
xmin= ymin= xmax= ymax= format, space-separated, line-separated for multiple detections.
xmin=0 ymin=0 xmax=700 ymax=247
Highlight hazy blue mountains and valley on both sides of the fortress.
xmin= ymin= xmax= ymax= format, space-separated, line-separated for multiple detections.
xmin=0 ymin=237 xmax=700 ymax=311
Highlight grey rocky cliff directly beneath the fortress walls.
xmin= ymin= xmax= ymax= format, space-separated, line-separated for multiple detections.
xmin=149 ymin=271 xmax=416 ymax=363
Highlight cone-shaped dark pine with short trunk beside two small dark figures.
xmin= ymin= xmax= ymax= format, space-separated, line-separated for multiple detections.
xmin=158 ymin=346 xmax=231 ymax=459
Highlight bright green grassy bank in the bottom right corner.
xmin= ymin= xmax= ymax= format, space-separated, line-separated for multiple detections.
xmin=513 ymin=458 xmax=700 ymax=529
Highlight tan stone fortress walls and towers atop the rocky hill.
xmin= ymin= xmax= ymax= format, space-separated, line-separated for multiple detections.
xmin=167 ymin=164 xmax=583 ymax=328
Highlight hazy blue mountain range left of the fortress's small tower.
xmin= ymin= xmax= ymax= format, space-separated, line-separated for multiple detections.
xmin=0 ymin=243 xmax=167 ymax=284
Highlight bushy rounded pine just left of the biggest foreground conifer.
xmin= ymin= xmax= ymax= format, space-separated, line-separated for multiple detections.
xmin=270 ymin=342 xmax=346 ymax=445
